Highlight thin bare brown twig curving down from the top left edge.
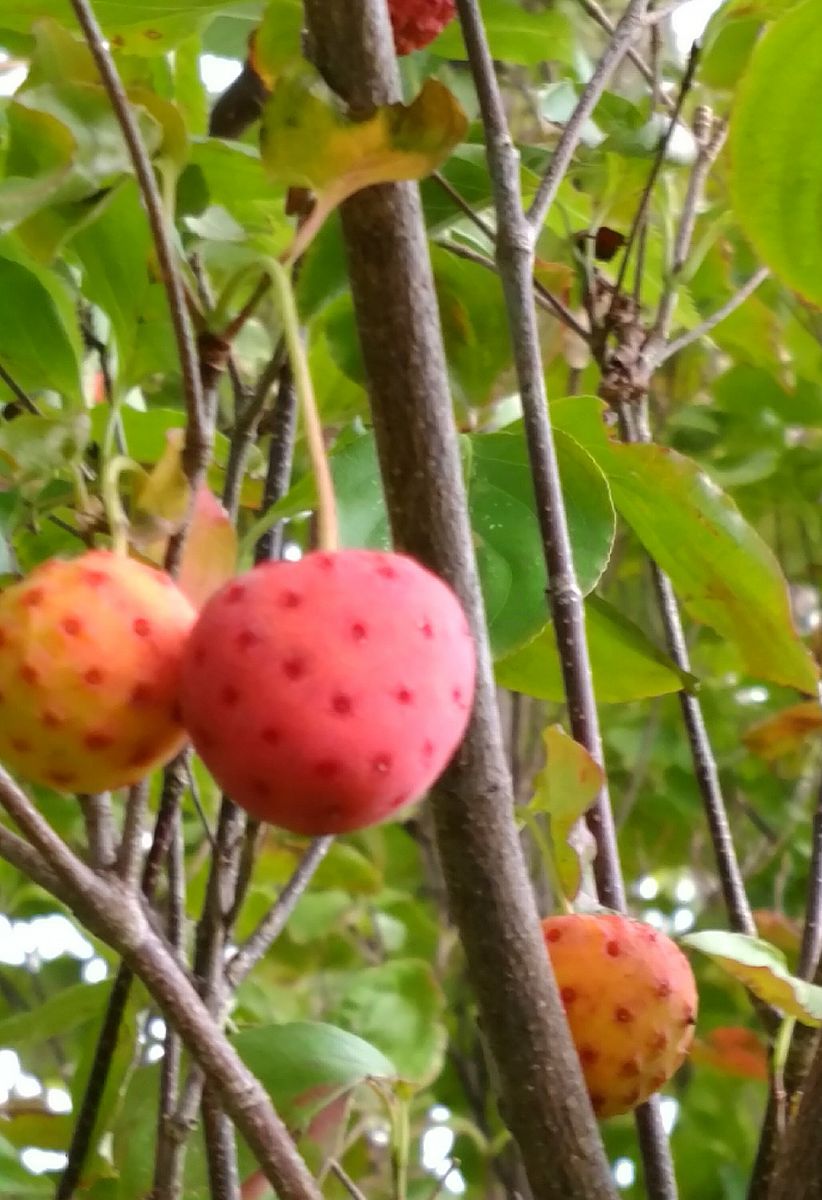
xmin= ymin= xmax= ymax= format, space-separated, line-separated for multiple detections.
xmin=71 ymin=0 xmax=212 ymax=486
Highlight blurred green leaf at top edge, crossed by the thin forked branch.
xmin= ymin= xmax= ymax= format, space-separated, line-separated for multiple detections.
xmin=431 ymin=0 xmax=574 ymax=66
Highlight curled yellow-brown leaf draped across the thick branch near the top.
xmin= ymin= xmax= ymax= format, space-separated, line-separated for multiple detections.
xmin=260 ymin=64 xmax=468 ymax=258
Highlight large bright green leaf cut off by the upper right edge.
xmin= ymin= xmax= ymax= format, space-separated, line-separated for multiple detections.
xmin=730 ymin=0 xmax=822 ymax=305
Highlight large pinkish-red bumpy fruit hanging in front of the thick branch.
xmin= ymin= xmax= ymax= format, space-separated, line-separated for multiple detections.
xmin=181 ymin=550 xmax=475 ymax=834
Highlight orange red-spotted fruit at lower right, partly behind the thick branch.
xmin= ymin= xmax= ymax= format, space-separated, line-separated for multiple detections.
xmin=542 ymin=914 xmax=697 ymax=1117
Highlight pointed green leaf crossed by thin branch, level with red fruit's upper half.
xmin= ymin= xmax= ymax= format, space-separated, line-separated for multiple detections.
xmin=494 ymin=596 xmax=691 ymax=704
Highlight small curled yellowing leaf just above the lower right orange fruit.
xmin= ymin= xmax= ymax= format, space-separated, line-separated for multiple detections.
xmin=528 ymin=725 xmax=602 ymax=900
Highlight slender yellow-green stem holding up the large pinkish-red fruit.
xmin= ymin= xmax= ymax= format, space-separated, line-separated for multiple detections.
xmin=268 ymin=259 xmax=340 ymax=550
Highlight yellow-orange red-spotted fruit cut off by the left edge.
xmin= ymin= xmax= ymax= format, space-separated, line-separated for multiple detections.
xmin=0 ymin=551 xmax=197 ymax=792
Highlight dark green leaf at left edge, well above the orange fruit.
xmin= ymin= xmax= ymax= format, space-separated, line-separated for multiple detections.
xmin=0 ymin=254 xmax=83 ymax=403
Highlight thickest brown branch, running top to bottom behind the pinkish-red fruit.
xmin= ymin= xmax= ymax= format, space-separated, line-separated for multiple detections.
xmin=306 ymin=0 xmax=616 ymax=1200
